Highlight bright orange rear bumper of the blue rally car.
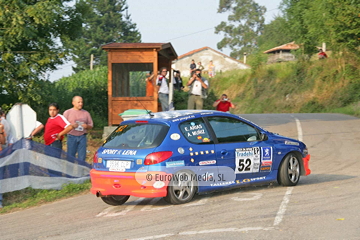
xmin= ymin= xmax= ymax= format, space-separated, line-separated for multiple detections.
xmin=90 ymin=169 xmax=172 ymax=198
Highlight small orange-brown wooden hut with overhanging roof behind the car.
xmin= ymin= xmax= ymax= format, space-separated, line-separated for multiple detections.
xmin=102 ymin=43 xmax=177 ymax=126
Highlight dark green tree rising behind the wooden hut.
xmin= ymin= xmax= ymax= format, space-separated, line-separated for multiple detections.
xmin=68 ymin=0 xmax=141 ymax=72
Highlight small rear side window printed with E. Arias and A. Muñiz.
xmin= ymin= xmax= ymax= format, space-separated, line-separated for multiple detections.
xmin=179 ymin=118 xmax=213 ymax=144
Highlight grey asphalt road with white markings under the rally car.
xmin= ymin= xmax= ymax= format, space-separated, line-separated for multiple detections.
xmin=0 ymin=114 xmax=360 ymax=240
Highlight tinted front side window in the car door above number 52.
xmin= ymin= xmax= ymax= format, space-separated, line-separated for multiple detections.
xmin=208 ymin=117 xmax=260 ymax=143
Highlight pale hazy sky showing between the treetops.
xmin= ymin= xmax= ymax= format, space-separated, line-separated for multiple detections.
xmin=49 ymin=0 xmax=281 ymax=81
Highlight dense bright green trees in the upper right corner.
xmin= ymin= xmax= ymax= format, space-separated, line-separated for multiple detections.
xmin=282 ymin=0 xmax=360 ymax=54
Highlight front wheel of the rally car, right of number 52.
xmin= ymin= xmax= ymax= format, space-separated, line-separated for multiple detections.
xmin=278 ymin=153 xmax=301 ymax=186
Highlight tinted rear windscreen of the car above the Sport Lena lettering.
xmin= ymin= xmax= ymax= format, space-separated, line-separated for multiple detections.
xmin=103 ymin=124 xmax=169 ymax=149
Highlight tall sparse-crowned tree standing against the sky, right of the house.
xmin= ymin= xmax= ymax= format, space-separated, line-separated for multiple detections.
xmin=215 ymin=0 xmax=266 ymax=59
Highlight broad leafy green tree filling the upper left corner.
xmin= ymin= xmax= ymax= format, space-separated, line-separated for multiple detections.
xmin=0 ymin=0 xmax=81 ymax=103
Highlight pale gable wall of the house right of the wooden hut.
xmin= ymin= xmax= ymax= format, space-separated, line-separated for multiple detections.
xmin=171 ymin=49 xmax=250 ymax=77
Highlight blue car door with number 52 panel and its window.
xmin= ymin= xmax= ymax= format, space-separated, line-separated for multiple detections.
xmin=207 ymin=116 xmax=273 ymax=183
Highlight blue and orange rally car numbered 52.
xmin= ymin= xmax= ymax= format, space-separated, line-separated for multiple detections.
xmin=90 ymin=110 xmax=311 ymax=205
